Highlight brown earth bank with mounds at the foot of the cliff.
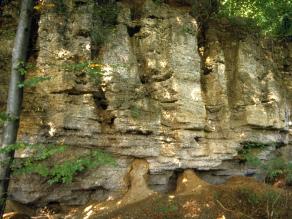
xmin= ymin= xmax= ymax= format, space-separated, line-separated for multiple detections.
xmin=4 ymin=170 xmax=292 ymax=219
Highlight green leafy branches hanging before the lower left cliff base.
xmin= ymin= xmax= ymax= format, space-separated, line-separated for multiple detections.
xmin=0 ymin=143 xmax=115 ymax=184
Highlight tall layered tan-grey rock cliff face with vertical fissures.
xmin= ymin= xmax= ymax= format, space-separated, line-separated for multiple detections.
xmin=0 ymin=0 xmax=292 ymax=205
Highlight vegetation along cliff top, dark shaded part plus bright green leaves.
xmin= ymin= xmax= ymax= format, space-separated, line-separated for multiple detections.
xmin=170 ymin=0 xmax=292 ymax=40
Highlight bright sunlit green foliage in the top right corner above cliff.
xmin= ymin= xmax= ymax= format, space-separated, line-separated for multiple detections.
xmin=219 ymin=0 xmax=292 ymax=38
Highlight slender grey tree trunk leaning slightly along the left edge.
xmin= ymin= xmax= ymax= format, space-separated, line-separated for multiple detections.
xmin=0 ymin=0 xmax=34 ymax=218
